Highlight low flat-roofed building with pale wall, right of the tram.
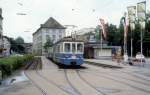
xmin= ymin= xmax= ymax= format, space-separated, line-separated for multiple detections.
xmin=84 ymin=42 xmax=120 ymax=59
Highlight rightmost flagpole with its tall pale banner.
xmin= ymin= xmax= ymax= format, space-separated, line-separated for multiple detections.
xmin=137 ymin=1 xmax=146 ymax=63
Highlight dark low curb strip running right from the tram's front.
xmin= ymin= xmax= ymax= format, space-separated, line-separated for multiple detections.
xmin=84 ymin=61 xmax=123 ymax=69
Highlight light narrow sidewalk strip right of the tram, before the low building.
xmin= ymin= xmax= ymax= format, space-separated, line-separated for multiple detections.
xmin=84 ymin=59 xmax=127 ymax=68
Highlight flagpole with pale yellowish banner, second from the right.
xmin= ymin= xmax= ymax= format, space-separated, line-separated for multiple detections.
xmin=127 ymin=6 xmax=136 ymax=59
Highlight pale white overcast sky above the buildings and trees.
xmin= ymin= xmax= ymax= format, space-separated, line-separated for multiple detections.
xmin=0 ymin=0 xmax=150 ymax=42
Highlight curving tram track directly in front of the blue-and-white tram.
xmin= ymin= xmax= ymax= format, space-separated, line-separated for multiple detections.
xmin=64 ymin=69 xmax=106 ymax=95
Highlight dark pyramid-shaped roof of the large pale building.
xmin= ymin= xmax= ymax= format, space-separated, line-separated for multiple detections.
xmin=41 ymin=17 xmax=65 ymax=29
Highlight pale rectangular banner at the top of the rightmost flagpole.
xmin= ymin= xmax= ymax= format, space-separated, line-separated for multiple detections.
xmin=137 ymin=1 xmax=146 ymax=22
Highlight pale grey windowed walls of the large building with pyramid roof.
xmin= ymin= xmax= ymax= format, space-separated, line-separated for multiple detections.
xmin=33 ymin=28 xmax=65 ymax=55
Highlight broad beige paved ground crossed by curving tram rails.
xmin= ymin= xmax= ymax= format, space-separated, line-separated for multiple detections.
xmin=1 ymin=57 xmax=150 ymax=95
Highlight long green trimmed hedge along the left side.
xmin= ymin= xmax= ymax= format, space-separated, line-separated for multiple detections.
xmin=0 ymin=55 xmax=34 ymax=77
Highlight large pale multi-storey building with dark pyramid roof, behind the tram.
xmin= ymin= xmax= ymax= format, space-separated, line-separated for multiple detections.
xmin=33 ymin=17 xmax=66 ymax=55
